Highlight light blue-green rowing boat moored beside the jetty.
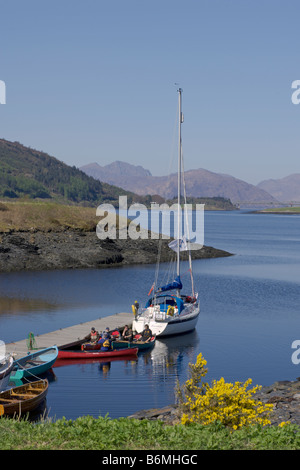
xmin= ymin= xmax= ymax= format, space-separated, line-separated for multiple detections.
xmin=10 ymin=346 xmax=58 ymax=380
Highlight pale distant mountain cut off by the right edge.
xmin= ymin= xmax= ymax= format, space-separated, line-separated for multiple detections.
xmin=257 ymin=173 xmax=300 ymax=202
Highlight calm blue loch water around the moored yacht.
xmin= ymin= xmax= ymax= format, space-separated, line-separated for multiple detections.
xmin=0 ymin=212 xmax=300 ymax=419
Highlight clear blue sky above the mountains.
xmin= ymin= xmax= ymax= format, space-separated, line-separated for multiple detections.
xmin=0 ymin=0 xmax=300 ymax=184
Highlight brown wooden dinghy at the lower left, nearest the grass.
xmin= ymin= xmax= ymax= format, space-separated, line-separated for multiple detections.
xmin=0 ymin=379 xmax=49 ymax=416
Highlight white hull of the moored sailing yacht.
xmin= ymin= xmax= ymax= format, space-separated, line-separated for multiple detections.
xmin=132 ymin=305 xmax=200 ymax=337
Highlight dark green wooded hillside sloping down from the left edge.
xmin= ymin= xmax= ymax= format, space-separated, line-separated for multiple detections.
xmin=0 ymin=139 xmax=136 ymax=205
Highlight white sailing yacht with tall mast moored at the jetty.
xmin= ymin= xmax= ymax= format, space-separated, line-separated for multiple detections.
xmin=132 ymin=88 xmax=200 ymax=337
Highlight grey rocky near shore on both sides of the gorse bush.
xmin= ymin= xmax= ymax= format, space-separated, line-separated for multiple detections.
xmin=128 ymin=377 xmax=300 ymax=426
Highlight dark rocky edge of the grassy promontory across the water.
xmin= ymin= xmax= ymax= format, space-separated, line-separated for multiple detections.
xmin=0 ymin=229 xmax=231 ymax=272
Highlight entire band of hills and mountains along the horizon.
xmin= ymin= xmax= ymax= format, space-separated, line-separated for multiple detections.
xmin=0 ymin=139 xmax=300 ymax=206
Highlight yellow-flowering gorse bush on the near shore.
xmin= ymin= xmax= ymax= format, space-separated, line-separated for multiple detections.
xmin=177 ymin=353 xmax=273 ymax=429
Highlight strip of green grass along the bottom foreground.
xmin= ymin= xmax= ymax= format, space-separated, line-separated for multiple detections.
xmin=0 ymin=416 xmax=300 ymax=451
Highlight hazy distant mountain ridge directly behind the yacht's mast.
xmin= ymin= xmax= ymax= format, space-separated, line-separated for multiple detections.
xmin=80 ymin=162 xmax=276 ymax=203
